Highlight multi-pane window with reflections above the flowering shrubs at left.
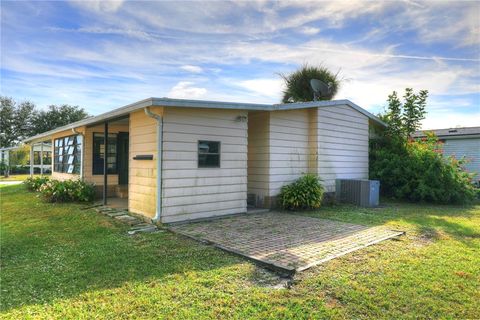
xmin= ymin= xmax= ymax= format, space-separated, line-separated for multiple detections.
xmin=53 ymin=135 xmax=83 ymax=174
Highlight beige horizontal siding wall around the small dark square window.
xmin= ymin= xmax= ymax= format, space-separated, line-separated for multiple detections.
xmin=162 ymin=108 xmax=247 ymax=222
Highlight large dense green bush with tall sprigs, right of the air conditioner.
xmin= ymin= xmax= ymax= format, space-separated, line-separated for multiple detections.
xmin=369 ymin=89 xmax=478 ymax=203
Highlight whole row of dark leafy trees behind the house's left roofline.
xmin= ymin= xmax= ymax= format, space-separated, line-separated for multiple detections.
xmin=0 ymin=96 xmax=89 ymax=148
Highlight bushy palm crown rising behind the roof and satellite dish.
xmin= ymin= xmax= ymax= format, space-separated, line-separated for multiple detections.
xmin=280 ymin=64 xmax=340 ymax=103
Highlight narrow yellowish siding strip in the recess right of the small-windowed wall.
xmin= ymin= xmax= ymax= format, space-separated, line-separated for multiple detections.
xmin=248 ymin=112 xmax=270 ymax=207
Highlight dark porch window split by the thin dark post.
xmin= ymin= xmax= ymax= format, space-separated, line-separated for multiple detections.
xmin=93 ymin=133 xmax=117 ymax=174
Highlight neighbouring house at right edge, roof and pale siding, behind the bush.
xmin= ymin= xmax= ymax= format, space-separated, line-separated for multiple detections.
xmin=413 ymin=127 xmax=480 ymax=181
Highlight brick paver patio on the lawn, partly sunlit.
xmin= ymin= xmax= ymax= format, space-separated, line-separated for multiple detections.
xmin=170 ymin=212 xmax=403 ymax=273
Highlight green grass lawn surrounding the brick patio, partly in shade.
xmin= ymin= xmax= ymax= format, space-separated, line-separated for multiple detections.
xmin=0 ymin=185 xmax=480 ymax=319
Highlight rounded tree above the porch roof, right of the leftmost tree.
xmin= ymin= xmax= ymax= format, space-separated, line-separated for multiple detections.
xmin=32 ymin=104 xmax=89 ymax=134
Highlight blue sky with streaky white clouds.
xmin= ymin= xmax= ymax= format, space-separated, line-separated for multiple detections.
xmin=1 ymin=0 xmax=480 ymax=129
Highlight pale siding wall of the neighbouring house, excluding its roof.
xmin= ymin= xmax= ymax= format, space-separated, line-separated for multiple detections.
xmin=443 ymin=138 xmax=480 ymax=181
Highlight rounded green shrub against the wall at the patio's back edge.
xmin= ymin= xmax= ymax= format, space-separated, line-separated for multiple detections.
xmin=279 ymin=174 xmax=324 ymax=210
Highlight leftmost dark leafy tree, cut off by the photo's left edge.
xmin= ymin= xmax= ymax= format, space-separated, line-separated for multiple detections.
xmin=0 ymin=96 xmax=36 ymax=148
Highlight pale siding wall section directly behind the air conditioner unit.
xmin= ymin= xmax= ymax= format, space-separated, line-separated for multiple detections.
xmin=317 ymin=106 xmax=369 ymax=191
